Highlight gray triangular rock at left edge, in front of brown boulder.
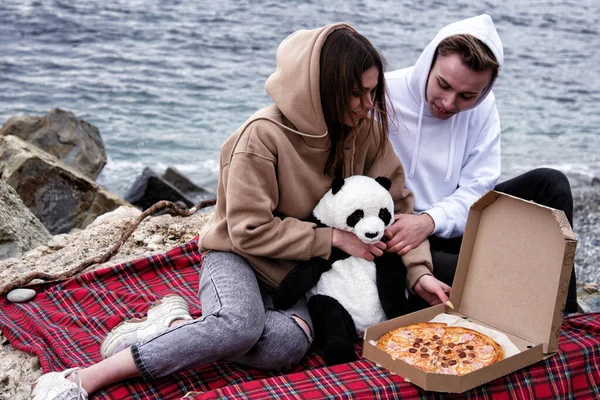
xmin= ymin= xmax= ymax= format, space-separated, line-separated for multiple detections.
xmin=0 ymin=180 xmax=52 ymax=260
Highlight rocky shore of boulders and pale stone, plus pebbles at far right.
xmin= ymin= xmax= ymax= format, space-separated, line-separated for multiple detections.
xmin=0 ymin=110 xmax=600 ymax=400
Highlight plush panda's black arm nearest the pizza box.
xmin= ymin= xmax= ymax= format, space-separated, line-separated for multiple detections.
xmin=375 ymin=253 xmax=409 ymax=319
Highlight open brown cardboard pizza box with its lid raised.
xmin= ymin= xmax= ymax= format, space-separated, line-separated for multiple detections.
xmin=363 ymin=191 xmax=577 ymax=393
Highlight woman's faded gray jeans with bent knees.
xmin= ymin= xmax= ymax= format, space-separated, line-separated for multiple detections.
xmin=131 ymin=251 xmax=313 ymax=379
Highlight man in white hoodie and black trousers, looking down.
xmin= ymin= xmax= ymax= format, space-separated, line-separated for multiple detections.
xmin=386 ymin=14 xmax=577 ymax=312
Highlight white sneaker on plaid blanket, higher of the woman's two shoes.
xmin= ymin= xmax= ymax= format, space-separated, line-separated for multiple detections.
xmin=100 ymin=294 xmax=193 ymax=359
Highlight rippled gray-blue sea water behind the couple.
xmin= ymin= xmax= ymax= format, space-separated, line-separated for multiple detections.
xmin=0 ymin=0 xmax=600 ymax=195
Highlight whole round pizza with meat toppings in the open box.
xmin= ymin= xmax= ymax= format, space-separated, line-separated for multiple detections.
xmin=377 ymin=322 xmax=504 ymax=375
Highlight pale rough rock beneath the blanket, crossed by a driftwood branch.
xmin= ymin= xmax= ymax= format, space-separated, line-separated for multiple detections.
xmin=0 ymin=206 xmax=210 ymax=400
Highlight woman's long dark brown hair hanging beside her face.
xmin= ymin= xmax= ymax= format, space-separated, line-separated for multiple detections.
xmin=319 ymin=29 xmax=388 ymax=177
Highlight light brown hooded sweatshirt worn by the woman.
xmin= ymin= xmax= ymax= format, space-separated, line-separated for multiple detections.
xmin=200 ymin=24 xmax=431 ymax=288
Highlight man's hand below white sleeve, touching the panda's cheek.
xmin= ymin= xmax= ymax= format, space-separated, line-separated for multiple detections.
xmin=384 ymin=213 xmax=435 ymax=256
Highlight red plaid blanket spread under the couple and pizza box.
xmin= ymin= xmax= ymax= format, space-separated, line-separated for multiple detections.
xmin=0 ymin=236 xmax=600 ymax=399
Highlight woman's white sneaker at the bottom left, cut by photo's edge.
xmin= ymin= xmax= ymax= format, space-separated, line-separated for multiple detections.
xmin=31 ymin=368 xmax=88 ymax=400
